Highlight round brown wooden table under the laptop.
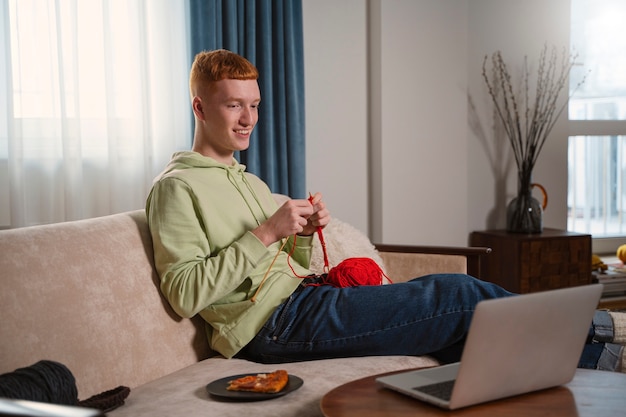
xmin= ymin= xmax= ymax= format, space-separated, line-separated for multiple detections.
xmin=321 ymin=369 xmax=626 ymax=417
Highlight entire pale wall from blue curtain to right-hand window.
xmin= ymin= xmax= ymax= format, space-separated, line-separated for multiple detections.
xmin=303 ymin=0 xmax=569 ymax=245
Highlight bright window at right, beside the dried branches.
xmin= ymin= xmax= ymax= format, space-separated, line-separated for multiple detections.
xmin=568 ymin=0 xmax=626 ymax=249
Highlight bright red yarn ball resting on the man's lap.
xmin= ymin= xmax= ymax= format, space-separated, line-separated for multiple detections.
xmin=326 ymin=258 xmax=389 ymax=288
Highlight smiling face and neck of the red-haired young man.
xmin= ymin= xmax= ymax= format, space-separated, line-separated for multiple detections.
xmin=192 ymin=79 xmax=261 ymax=165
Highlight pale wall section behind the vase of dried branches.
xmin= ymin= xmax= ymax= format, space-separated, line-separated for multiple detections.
xmin=468 ymin=0 xmax=570 ymax=234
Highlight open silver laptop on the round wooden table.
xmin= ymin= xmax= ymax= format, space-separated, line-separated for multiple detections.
xmin=376 ymin=284 xmax=602 ymax=410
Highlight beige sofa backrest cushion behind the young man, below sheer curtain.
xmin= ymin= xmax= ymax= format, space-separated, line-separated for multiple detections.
xmin=0 ymin=210 xmax=209 ymax=400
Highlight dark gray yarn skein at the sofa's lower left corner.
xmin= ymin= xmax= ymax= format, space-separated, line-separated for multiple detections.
xmin=0 ymin=360 xmax=78 ymax=405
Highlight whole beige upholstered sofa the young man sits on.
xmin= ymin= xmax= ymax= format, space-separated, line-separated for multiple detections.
xmin=0 ymin=200 xmax=486 ymax=417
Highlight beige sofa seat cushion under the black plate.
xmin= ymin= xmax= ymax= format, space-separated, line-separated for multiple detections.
xmin=107 ymin=356 xmax=437 ymax=417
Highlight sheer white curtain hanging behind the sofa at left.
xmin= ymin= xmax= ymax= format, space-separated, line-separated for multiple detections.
xmin=0 ymin=0 xmax=192 ymax=227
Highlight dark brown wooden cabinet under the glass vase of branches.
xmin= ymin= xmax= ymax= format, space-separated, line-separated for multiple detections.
xmin=469 ymin=228 xmax=592 ymax=294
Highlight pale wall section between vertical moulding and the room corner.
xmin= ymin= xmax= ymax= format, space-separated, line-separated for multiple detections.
xmin=372 ymin=0 xmax=467 ymax=244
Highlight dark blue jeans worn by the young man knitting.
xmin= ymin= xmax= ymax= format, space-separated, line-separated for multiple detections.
xmin=237 ymin=274 xmax=620 ymax=368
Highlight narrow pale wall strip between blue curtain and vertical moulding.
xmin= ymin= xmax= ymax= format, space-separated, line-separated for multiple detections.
xmin=303 ymin=0 xmax=369 ymax=232
